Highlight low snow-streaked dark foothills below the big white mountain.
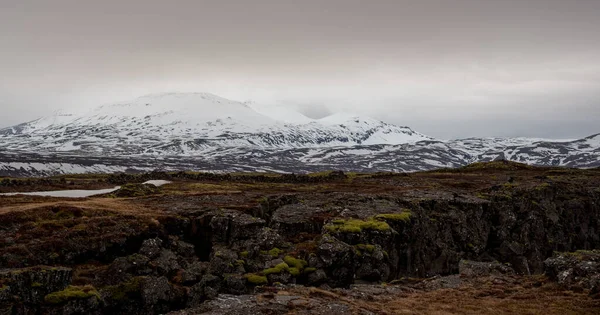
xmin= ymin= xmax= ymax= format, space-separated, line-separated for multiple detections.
xmin=0 ymin=138 xmax=600 ymax=176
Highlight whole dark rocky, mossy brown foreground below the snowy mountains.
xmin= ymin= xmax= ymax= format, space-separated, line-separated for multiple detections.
xmin=0 ymin=162 xmax=600 ymax=314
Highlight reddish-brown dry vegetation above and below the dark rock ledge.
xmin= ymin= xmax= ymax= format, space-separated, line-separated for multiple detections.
xmin=0 ymin=162 xmax=600 ymax=314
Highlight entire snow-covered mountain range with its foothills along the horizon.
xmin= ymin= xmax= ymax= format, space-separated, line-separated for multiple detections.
xmin=0 ymin=93 xmax=600 ymax=176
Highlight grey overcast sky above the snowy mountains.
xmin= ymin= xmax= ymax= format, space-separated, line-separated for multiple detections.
xmin=0 ymin=0 xmax=600 ymax=138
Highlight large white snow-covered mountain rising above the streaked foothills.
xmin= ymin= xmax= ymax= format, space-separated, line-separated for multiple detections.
xmin=0 ymin=93 xmax=430 ymax=155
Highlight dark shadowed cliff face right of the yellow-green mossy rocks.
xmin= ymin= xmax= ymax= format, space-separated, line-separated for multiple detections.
xmin=391 ymin=191 xmax=600 ymax=276
